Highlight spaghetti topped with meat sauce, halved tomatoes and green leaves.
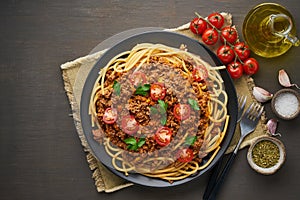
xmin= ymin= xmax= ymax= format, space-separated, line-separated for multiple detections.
xmin=89 ymin=43 xmax=229 ymax=182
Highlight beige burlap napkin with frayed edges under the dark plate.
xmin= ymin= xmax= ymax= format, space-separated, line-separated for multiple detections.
xmin=61 ymin=13 xmax=267 ymax=192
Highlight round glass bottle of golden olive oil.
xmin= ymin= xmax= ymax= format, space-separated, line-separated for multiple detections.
xmin=243 ymin=3 xmax=300 ymax=58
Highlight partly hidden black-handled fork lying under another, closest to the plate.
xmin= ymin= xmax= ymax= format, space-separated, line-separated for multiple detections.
xmin=203 ymin=95 xmax=247 ymax=198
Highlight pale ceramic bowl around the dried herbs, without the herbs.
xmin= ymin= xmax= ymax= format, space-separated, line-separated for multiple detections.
xmin=247 ymin=136 xmax=286 ymax=175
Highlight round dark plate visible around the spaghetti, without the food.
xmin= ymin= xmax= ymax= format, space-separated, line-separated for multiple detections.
xmin=80 ymin=31 xmax=237 ymax=187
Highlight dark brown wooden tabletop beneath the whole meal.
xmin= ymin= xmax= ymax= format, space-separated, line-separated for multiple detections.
xmin=0 ymin=0 xmax=300 ymax=200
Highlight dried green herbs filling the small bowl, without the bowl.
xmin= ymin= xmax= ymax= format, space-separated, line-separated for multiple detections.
xmin=252 ymin=140 xmax=280 ymax=168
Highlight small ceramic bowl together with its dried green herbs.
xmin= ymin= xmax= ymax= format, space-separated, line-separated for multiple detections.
xmin=247 ymin=136 xmax=286 ymax=175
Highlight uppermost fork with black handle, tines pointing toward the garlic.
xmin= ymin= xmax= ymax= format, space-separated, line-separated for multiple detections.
xmin=203 ymin=103 xmax=263 ymax=200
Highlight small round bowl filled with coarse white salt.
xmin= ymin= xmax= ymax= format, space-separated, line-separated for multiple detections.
xmin=271 ymin=89 xmax=300 ymax=120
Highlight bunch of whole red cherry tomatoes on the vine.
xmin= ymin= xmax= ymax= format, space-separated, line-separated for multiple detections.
xmin=190 ymin=12 xmax=259 ymax=79
